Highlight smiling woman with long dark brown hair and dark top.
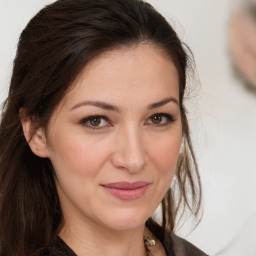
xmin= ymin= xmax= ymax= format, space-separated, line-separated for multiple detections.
xmin=0 ymin=0 xmax=205 ymax=256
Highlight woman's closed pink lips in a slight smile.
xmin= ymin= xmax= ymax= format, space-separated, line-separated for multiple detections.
xmin=102 ymin=181 xmax=150 ymax=200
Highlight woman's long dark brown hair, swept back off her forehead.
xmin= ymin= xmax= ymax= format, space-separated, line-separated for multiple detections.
xmin=0 ymin=0 xmax=201 ymax=256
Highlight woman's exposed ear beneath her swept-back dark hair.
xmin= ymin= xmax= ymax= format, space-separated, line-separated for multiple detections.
xmin=20 ymin=110 xmax=48 ymax=157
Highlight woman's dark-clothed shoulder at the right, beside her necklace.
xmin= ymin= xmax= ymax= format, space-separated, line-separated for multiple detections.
xmin=167 ymin=234 xmax=207 ymax=256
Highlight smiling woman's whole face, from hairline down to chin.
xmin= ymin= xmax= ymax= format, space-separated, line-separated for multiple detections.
xmin=43 ymin=45 xmax=182 ymax=230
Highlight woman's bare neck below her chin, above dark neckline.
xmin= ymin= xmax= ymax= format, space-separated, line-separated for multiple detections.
xmin=59 ymin=218 xmax=148 ymax=256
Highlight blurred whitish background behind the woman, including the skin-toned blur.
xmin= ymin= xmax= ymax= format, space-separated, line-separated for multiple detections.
xmin=0 ymin=0 xmax=256 ymax=256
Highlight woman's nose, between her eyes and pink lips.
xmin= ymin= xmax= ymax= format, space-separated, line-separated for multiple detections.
xmin=112 ymin=124 xmax=147 ymax=173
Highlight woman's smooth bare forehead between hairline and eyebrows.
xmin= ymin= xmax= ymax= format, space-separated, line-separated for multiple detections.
xmin=61 ymin=44 xmax=179 ymax=108
